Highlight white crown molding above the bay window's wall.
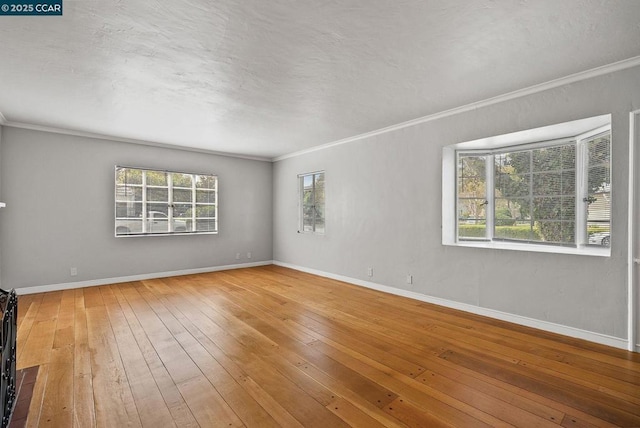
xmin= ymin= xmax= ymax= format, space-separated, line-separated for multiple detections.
xmin=271 ymin=56 xmax=640 ymax=162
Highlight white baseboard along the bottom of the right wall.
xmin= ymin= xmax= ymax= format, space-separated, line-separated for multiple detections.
xmin=273 ymin=260 xmax=640 ymax=350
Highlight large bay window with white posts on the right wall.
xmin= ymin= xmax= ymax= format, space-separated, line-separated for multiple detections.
xmin=443 ymin=114 xmax=611 ymax=254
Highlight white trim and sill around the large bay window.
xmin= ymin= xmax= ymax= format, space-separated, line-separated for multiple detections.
xmin=442 ymin=115 xmax=613 ymax=257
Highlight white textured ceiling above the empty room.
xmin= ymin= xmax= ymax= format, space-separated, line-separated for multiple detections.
xmin=0 ymin=0 xmax=640 ymax=158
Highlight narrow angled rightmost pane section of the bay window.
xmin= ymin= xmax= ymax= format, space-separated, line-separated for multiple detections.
xmin=585 ymin=132 xmax=611 ymax=247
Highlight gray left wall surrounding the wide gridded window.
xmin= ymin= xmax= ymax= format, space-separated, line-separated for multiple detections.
xmin=0 ymin=127 xmax=272 ymax=288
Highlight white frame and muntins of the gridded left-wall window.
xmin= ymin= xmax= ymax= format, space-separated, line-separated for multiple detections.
xmin=113 ymin=165 xmax=219 ymax=238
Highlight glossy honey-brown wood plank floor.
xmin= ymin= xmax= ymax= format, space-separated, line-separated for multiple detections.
xmin=18 ymin=266 xmax=640 ymax=428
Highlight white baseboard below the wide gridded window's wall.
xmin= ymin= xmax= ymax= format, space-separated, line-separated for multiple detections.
xmin=15 ymin=260 xmax=273 ymax=295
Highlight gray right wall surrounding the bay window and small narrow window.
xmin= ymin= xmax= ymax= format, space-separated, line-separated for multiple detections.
xmin=274 ymin=68 xmax=640 ymax=338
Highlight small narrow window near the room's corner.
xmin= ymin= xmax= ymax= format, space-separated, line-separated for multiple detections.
xmin=298 ymin=172 xmax=325 ymax=234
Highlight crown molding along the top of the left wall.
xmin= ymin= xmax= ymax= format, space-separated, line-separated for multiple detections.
xmin=0 ymin=118 xmax=271 ymax=162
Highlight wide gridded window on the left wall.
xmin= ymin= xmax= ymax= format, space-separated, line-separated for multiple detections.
xmin=115 ymin=166 xmax=218 ymax=236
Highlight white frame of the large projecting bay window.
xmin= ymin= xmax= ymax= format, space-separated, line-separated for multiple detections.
xmin=442 ymin=115 xmax=613 ymax=256
